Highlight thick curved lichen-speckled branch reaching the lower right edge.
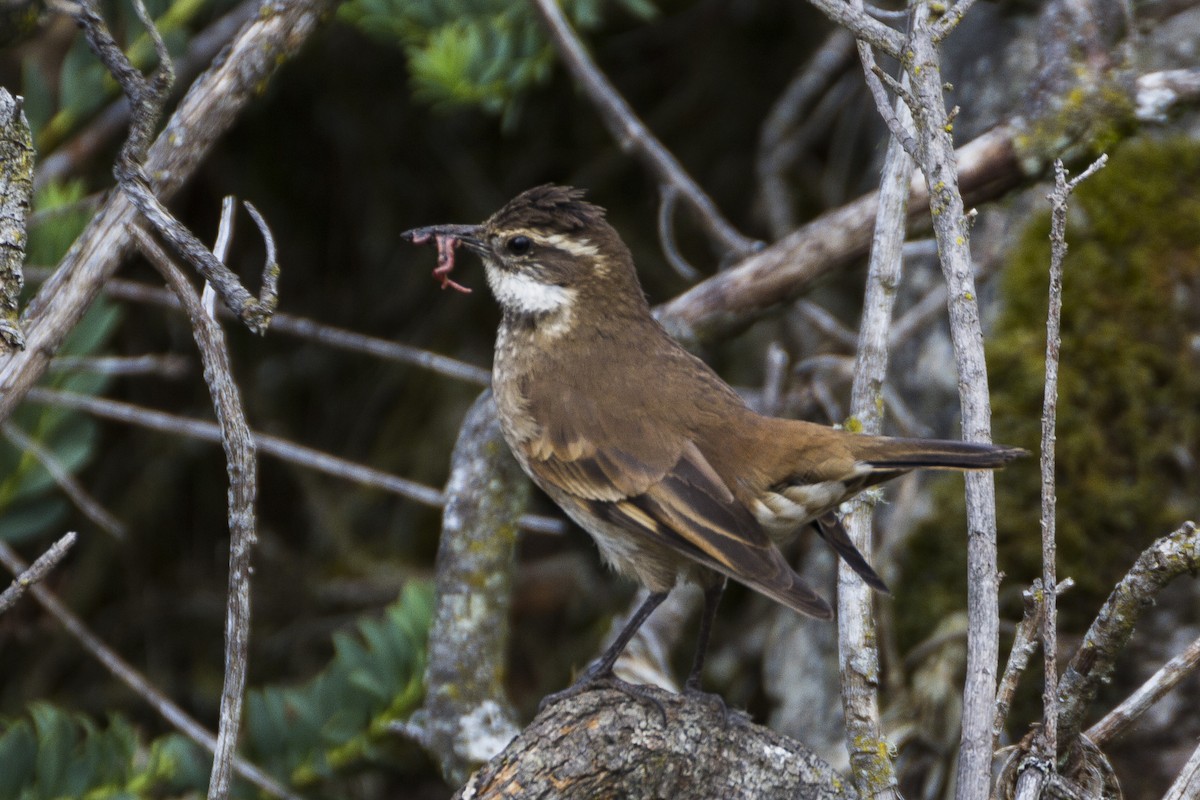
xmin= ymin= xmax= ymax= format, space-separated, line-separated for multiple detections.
xmin=1058 ymin=522 xmax=1200 ymax=746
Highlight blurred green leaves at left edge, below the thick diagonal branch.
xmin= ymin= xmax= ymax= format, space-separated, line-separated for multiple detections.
xmin=0 ymin=178 xmax=121 ymax=542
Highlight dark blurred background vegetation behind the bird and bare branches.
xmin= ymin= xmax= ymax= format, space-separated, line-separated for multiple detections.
xmin=0 ymin=0 xmax=1200 ymax=800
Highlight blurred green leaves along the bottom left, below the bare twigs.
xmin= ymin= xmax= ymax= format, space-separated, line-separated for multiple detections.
xmin=0 ymin=583 xmax=433 ymax=800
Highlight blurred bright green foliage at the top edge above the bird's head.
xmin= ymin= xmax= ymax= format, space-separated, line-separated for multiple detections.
xmin=340 ymin=0 xmax=654 ymax=118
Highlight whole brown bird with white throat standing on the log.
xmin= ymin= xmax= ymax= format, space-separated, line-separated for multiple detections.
xmin=403 ymin=186 xmax=1025 ymax=699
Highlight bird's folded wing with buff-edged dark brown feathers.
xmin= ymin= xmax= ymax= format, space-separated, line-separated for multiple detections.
xmin=522 ymin=419 xmax=833 ymax=619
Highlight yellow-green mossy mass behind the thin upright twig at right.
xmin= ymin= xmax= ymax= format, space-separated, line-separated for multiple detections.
xmin=896 ymin=138 xmax=1200 ymax=636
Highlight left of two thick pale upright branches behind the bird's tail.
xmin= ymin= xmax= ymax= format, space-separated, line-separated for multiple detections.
xmin=838 ymin=74 xmax=912 ymax=798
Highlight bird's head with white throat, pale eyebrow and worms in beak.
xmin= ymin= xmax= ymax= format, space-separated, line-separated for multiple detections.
xmin=402 ymin=185 xmax=646 ymax=318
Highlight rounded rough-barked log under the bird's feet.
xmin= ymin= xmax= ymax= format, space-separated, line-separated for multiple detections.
xmin=455 ymin=687 xmax=858 ymax=800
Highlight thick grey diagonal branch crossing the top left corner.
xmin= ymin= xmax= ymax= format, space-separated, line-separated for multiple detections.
xmin=0 ymin=0 xmax=334 ymax=419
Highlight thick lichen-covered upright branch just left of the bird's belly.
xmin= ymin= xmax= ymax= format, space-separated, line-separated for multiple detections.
xmin=396 ymin=390 xmax=529 ymax=784
